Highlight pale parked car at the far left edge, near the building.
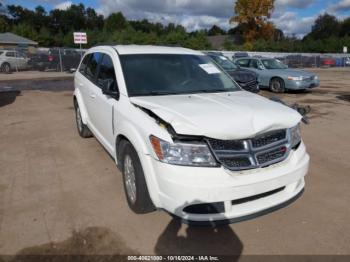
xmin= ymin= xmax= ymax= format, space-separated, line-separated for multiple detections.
xmin=0 ymin=50 xmax=28 ymax=74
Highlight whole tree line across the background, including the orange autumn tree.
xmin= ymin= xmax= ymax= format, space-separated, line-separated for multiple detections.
xmin=0 ymin=0 xmax=350 ymax=53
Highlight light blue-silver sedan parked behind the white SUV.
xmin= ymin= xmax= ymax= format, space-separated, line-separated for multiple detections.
xmin=235 ymin=57 xmax=320 ymax=93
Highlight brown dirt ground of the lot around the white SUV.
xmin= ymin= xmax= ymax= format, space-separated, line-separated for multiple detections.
xmin=0 ymin=69 xmax=350 ymax=260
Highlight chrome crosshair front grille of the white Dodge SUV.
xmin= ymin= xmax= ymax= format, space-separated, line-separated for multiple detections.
xmin=207 ymin=129 xmax=290 ymax=171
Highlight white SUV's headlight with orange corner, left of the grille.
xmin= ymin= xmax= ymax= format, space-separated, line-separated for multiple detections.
xmin=150 ymin=136 xmax=217 ymax=167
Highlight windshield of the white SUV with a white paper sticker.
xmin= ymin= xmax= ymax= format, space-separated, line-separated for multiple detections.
xmin=120 ymin=54 xmax=240 ymax=96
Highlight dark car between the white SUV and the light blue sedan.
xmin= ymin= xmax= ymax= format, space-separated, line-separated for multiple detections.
xmin=207 ymin=52 xmax=260 ymax=93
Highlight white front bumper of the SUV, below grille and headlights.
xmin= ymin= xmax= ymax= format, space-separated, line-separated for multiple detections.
xmin=145 ymin=143 xmax=309 ymax=223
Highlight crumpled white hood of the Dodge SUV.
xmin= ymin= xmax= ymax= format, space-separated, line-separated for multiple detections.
xmin=130 ymin=91 xmax=302 ymax=140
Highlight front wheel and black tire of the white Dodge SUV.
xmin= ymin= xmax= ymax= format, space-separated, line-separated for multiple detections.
xmin=119 ymin=140 xmax=156 ymax=214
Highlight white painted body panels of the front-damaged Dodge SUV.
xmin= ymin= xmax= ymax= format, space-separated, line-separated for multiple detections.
xmin=74 ymin=46 xmax=309 ymax=221
